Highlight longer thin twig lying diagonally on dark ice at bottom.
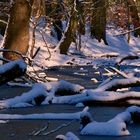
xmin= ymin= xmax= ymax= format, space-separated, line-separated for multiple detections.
xmin=42 ymin=120 xmax=75 ymax=136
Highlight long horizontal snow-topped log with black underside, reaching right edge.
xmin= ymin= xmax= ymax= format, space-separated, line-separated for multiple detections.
xmin=52 ymin=90 xmax=140 ymax=106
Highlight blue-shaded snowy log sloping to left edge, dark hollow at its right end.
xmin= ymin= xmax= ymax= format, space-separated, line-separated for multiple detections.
xmin=0 ymin=84 xmax=47 ymax=108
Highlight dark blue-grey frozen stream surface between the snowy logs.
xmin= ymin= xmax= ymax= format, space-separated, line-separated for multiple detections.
xmin=0 ymin=66 xmax=140 ymax=140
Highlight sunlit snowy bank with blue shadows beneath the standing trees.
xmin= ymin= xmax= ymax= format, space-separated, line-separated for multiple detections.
xmin=27 ymin=29 xmax=140 ymax=67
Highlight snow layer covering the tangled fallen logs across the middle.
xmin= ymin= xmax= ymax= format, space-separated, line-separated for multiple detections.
xmin=0 ymin=78 xmax=140 ymax=108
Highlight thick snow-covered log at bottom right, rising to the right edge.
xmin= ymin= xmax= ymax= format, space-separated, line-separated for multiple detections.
xmin=80 ymin=106 xmax=140 ymax=136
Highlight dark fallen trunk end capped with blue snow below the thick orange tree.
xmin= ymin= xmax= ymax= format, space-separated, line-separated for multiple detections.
xmin=0 ymin=60 xmax=26 ymax=85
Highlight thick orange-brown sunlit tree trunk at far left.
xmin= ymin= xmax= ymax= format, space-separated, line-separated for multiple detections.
xmin=3 ymin=0 xmax=33 ymax=60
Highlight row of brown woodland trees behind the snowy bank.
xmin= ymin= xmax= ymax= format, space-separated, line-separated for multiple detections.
xmin=0 ymin=0 xmax=140 ymax=60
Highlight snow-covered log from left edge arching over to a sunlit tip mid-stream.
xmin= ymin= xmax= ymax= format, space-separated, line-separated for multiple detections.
xmin=0 ymin=80 xmax=84 ymax=108
